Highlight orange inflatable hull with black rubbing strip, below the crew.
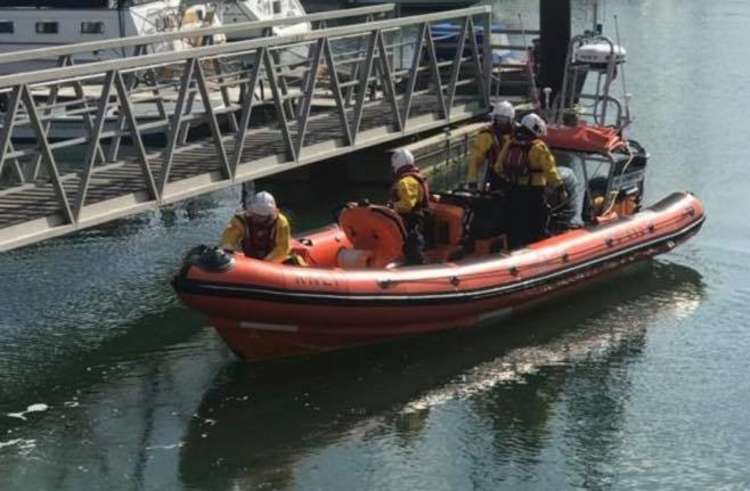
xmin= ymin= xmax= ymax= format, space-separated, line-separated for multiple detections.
xmin=174 ymin=193 xmax=704 ymax=360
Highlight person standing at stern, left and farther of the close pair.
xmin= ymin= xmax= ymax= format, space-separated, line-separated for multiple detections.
xmin=466 ymin=101 xmax=516 ymax=189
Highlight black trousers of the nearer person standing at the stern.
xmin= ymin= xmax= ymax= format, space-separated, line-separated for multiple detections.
xmin=508 ymin=186 xmax=548 ymax=249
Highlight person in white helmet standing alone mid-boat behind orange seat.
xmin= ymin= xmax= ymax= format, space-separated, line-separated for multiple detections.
xmin=391 ymin=149 xmax=430 ymax=264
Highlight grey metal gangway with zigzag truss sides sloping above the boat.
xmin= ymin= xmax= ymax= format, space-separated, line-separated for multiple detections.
xmin=0 ymin=6 xmax=492 ymax=251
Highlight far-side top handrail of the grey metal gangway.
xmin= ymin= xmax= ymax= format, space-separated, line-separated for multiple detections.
xmin=0 ymin=3 xmax=396 ymax=65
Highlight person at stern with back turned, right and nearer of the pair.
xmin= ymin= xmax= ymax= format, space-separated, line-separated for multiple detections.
xmin=495 ymin=113 xmax=562 ymax=248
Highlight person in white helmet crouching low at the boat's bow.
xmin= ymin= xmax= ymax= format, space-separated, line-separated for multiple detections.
xmin=221 ymin=191 xmax=299 ymax=264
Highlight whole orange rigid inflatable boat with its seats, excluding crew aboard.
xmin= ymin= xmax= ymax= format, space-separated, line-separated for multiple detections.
xmin=174 ymin=125 xmax=704 ymax=360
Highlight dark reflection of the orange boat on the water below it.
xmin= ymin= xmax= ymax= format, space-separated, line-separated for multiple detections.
xmin=179 ymin=261 xmax=704 ymax=489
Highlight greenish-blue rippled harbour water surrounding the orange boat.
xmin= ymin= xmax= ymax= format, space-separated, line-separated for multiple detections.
xmin=0 ymin=0 xmax=750 ymax=490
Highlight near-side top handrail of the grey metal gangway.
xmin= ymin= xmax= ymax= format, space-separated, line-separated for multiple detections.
xmin=0 ymin=5 xmax=492 ymax=91
